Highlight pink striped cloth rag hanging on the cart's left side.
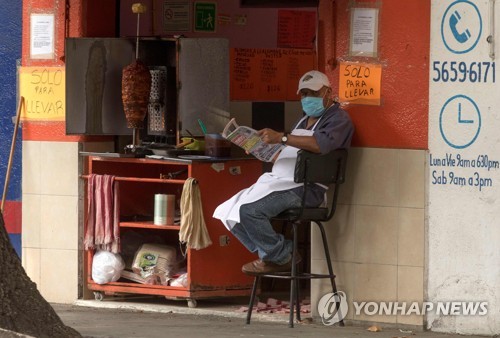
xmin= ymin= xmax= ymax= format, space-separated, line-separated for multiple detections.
xmin=84 ymin=174 xmax=120 ymax=253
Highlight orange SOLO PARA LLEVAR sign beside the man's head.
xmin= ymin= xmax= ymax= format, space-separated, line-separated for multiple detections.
xmin=339 ymin=62 xmax=382 ymax=105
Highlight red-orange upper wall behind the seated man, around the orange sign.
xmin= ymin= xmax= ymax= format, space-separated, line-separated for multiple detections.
xmin=319 ymin=0 xmax=431 ymax=149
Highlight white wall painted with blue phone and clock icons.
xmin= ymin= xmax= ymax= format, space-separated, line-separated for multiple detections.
xmin=425 ymin=0 xmax=500 ymax=335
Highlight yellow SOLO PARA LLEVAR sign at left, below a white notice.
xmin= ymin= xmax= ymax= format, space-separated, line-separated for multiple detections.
xmin=19 ymin=67 xmax=66 ymax=121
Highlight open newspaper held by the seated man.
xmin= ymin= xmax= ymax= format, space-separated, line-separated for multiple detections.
xmin=222 ymin=118 xmax=285 ymax=162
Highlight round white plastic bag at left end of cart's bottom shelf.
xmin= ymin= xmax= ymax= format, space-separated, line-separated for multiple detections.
xmin=92 ymin=250 xmax=125 ymax=284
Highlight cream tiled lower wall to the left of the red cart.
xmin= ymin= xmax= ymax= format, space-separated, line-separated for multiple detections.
xmin=22 ymin=141 xmax=79 ymax=303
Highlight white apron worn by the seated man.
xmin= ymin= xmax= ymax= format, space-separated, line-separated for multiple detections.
xmin=213 ymin=116 xmax=321 ymax=230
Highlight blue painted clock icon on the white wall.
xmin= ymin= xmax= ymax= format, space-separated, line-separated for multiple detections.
xmin=439 ymin=95 xmax=481 ymax=149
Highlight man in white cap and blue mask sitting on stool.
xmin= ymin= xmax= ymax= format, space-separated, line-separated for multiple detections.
xmin=213 ymin=70 xmax=354 ymax=274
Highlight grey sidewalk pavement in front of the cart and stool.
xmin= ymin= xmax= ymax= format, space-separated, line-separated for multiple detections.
xmin=52 ymin=297 xmax=488 ymax=338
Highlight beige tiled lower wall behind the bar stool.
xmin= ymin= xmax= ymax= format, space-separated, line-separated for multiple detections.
xmin=311 ymin=147 xmax=427 ymax=328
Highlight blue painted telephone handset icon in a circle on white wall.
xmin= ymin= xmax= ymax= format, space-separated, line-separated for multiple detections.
xmin=441 ymin=0 xmax=483 ymax=54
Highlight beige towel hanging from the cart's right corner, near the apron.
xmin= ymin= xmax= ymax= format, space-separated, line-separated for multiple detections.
xmin=179 ymin=178 xmax=212 ymax=250
